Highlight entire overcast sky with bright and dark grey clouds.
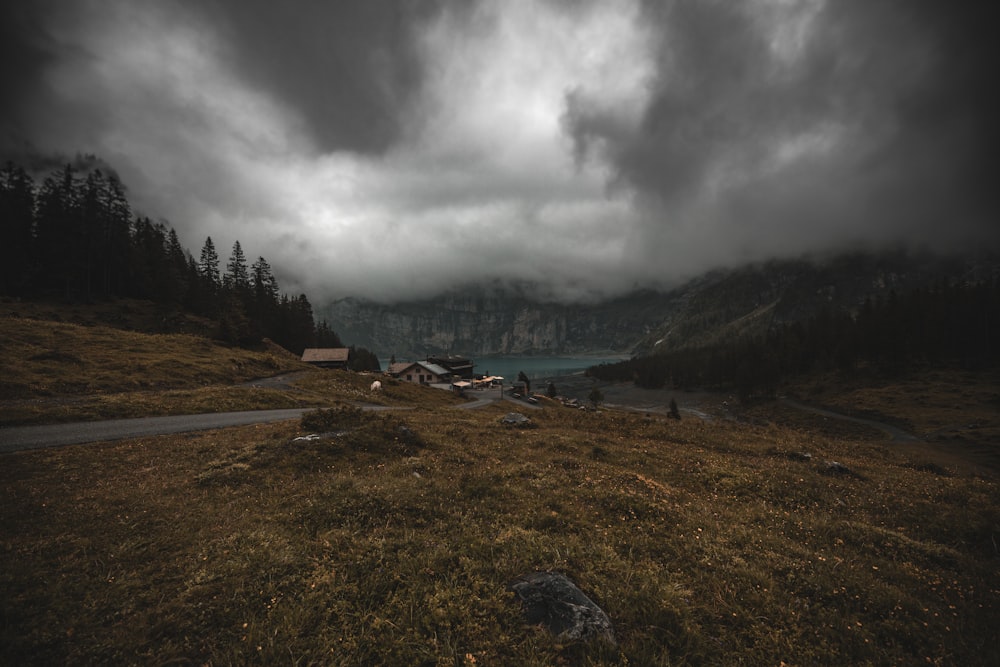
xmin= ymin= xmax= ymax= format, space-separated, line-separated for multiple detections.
xmin=0 ymin=0 xmax=1000 ymax=303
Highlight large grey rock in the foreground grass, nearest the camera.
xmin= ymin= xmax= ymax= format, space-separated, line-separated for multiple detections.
xmin=510 ymin=572 xmax=616 ymax=644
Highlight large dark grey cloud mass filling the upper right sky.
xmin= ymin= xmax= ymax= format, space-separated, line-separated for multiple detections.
xmin=564 ymin=0 xmax=1000 ymax=254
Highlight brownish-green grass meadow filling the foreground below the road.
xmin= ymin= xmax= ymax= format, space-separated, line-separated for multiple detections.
xmin=0 ymin=310 xmax=1000 ymax=665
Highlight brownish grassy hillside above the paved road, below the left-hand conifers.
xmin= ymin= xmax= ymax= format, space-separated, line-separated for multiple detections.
xmin=0 ymin=304 xmax=460 ymax=426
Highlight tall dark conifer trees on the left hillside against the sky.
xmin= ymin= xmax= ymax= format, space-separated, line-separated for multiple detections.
xmin=0 ymin=163 xmax=377 ymax=368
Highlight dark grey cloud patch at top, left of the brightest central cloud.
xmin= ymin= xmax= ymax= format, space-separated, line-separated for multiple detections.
xmin=187 ymin=0 xmax=454 ymax=152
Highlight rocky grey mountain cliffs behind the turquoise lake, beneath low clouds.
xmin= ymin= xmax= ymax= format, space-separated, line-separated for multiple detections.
xmin=326 ymin=253 xmax=1000 ymax=359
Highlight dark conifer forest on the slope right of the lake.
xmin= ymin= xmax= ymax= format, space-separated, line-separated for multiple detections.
xmin=588 ymin=282 xmax=1000 ymax=400
